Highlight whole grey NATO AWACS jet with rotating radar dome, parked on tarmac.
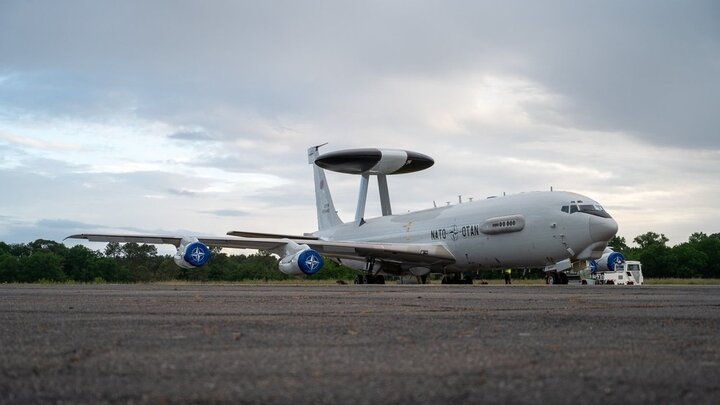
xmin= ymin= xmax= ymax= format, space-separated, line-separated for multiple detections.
xmin=68 ymin=145 xmax=618 ymax=283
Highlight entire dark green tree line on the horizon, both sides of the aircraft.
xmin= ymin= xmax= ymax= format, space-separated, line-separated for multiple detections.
xmin=0 ymin=232 xmax=720 ymax=283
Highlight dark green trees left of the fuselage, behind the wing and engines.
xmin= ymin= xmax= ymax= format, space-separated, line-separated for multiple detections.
xmin=0 ymin=239 xmax=356 ymax=283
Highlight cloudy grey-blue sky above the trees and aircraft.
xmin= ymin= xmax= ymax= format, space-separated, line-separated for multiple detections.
xmin=0 ymin=0 xmax=720 ymax=249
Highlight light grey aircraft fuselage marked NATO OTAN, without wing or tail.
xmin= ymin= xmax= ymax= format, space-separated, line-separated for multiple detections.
xmin=316 ymin=191 xmax=617 ymax=272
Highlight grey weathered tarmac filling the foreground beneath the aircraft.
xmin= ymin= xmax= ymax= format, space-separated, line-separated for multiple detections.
xmin=0 ymin=284 xmax=720 ymax=404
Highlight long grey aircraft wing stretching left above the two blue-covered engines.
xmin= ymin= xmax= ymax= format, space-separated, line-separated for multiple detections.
xmin=66 ymin=234 xmax=455 ymax=265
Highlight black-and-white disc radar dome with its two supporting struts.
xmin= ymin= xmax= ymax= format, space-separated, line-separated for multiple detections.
xmin=314 ymin=149 xmax=435 ymax=226
